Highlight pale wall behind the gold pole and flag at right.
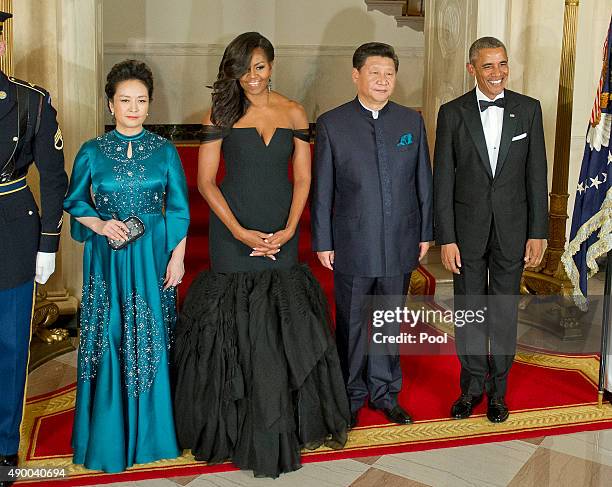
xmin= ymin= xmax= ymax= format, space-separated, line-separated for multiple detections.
xmin=508 ymin=0 xmax=612 ymax=243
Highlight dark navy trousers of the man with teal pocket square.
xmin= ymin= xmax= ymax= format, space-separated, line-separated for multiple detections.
xmin=334 ymin=271 xmax=410 ymax=412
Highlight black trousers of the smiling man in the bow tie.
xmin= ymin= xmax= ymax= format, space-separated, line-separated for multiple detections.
xmin=453 ymin=222 xmax=524 ymax=397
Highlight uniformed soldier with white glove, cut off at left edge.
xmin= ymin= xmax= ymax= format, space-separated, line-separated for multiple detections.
xmin=0 ymin=11 xmax=68 ymax=487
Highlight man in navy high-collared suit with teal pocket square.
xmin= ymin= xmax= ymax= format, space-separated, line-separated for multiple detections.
xmin=311 ymin=42 xmax=433 ymax=426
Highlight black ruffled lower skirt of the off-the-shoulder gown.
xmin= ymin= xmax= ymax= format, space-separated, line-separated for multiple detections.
xmin=173 ymin=265 xmax=350 ymax=477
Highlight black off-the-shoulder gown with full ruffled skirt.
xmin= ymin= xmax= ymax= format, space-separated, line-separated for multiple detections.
xmin=173 ymin=127 xmax=350 ymax=477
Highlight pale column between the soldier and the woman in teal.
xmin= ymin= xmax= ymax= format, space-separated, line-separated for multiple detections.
xmin=13 ymin=0 xmax=104 ymax=313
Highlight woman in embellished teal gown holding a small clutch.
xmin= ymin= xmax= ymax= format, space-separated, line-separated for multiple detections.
xmin=64 ymin=61 xmax=189 ymax=472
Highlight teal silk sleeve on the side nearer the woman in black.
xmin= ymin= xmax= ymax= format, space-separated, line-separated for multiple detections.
xmin=166 ymin=145 xmax=189 ymax=252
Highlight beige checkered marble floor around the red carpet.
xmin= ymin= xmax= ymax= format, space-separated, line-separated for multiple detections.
xmin=23 ymin=264 xmax=612 ymax=487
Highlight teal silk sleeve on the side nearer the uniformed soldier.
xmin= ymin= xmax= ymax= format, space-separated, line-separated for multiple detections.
xmin=64 ymin=144 xmax=100 ymax=242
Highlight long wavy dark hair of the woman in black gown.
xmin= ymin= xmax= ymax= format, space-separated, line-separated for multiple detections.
xmin=210 ymin=32 xmax=274 ymax=127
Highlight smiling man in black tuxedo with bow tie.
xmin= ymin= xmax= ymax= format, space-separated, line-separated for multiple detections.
xmin=434 ymin=37 xmax=548 ymax=423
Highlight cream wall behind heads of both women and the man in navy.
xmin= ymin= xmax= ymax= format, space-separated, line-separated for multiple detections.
xmin=104 ymin=0 xmax=424 ymax=123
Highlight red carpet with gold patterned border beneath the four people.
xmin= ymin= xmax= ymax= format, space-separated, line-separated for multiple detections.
xmin=17 ymin=147 xmax=612 ymax=486
